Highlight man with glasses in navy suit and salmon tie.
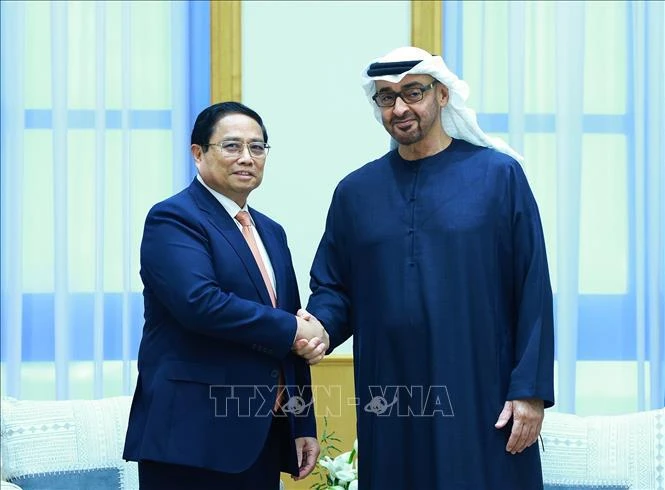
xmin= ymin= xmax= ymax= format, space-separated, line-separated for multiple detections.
xmin=123 ymin=102 xmax=328 ymax=490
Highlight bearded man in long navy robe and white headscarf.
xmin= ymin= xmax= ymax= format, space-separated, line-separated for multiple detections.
xmin=301 ymin=48 xmax=554 ymax=490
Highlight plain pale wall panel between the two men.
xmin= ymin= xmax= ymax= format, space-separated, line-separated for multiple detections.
xmin=242 ymin=1 xmax=411 ymax=353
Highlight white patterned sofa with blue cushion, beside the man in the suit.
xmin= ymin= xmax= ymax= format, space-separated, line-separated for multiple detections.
xmin=0 ymin=396 xmax=138 ymax=490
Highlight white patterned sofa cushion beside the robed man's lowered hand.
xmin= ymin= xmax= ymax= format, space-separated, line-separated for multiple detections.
xmin=541 ymin=409 xmax=665 ymax=490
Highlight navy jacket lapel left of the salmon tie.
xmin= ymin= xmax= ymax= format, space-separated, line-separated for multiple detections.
xmin=189 ymin=179 xmax=272 ymax=305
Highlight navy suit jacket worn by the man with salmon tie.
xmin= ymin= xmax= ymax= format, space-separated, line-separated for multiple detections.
xmin=123 ymin=179 xmax=316 ymax=474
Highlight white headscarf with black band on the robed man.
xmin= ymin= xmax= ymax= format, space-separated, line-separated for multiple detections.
xmin=362 ymin=47 xmax=524 ymax=163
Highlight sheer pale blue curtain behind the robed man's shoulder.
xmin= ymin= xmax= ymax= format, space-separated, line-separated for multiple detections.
xmin=442 ymin=1 xmax=665 ymax=413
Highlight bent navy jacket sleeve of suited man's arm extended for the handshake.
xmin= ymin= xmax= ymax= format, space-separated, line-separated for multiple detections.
xmin=141 ymin=203 xmax=296 ymax=359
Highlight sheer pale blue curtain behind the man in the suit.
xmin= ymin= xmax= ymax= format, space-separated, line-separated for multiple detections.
xmin=1 ymin=1 xmax=210 ymax=399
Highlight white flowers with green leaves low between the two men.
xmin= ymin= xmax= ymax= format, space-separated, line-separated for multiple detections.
xmin=310 ymin=417 xmax=358 ymax=490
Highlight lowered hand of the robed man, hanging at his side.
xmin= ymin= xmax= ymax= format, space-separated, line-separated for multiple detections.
xmin=494 ymin=398 xmax=545 ymax=454
